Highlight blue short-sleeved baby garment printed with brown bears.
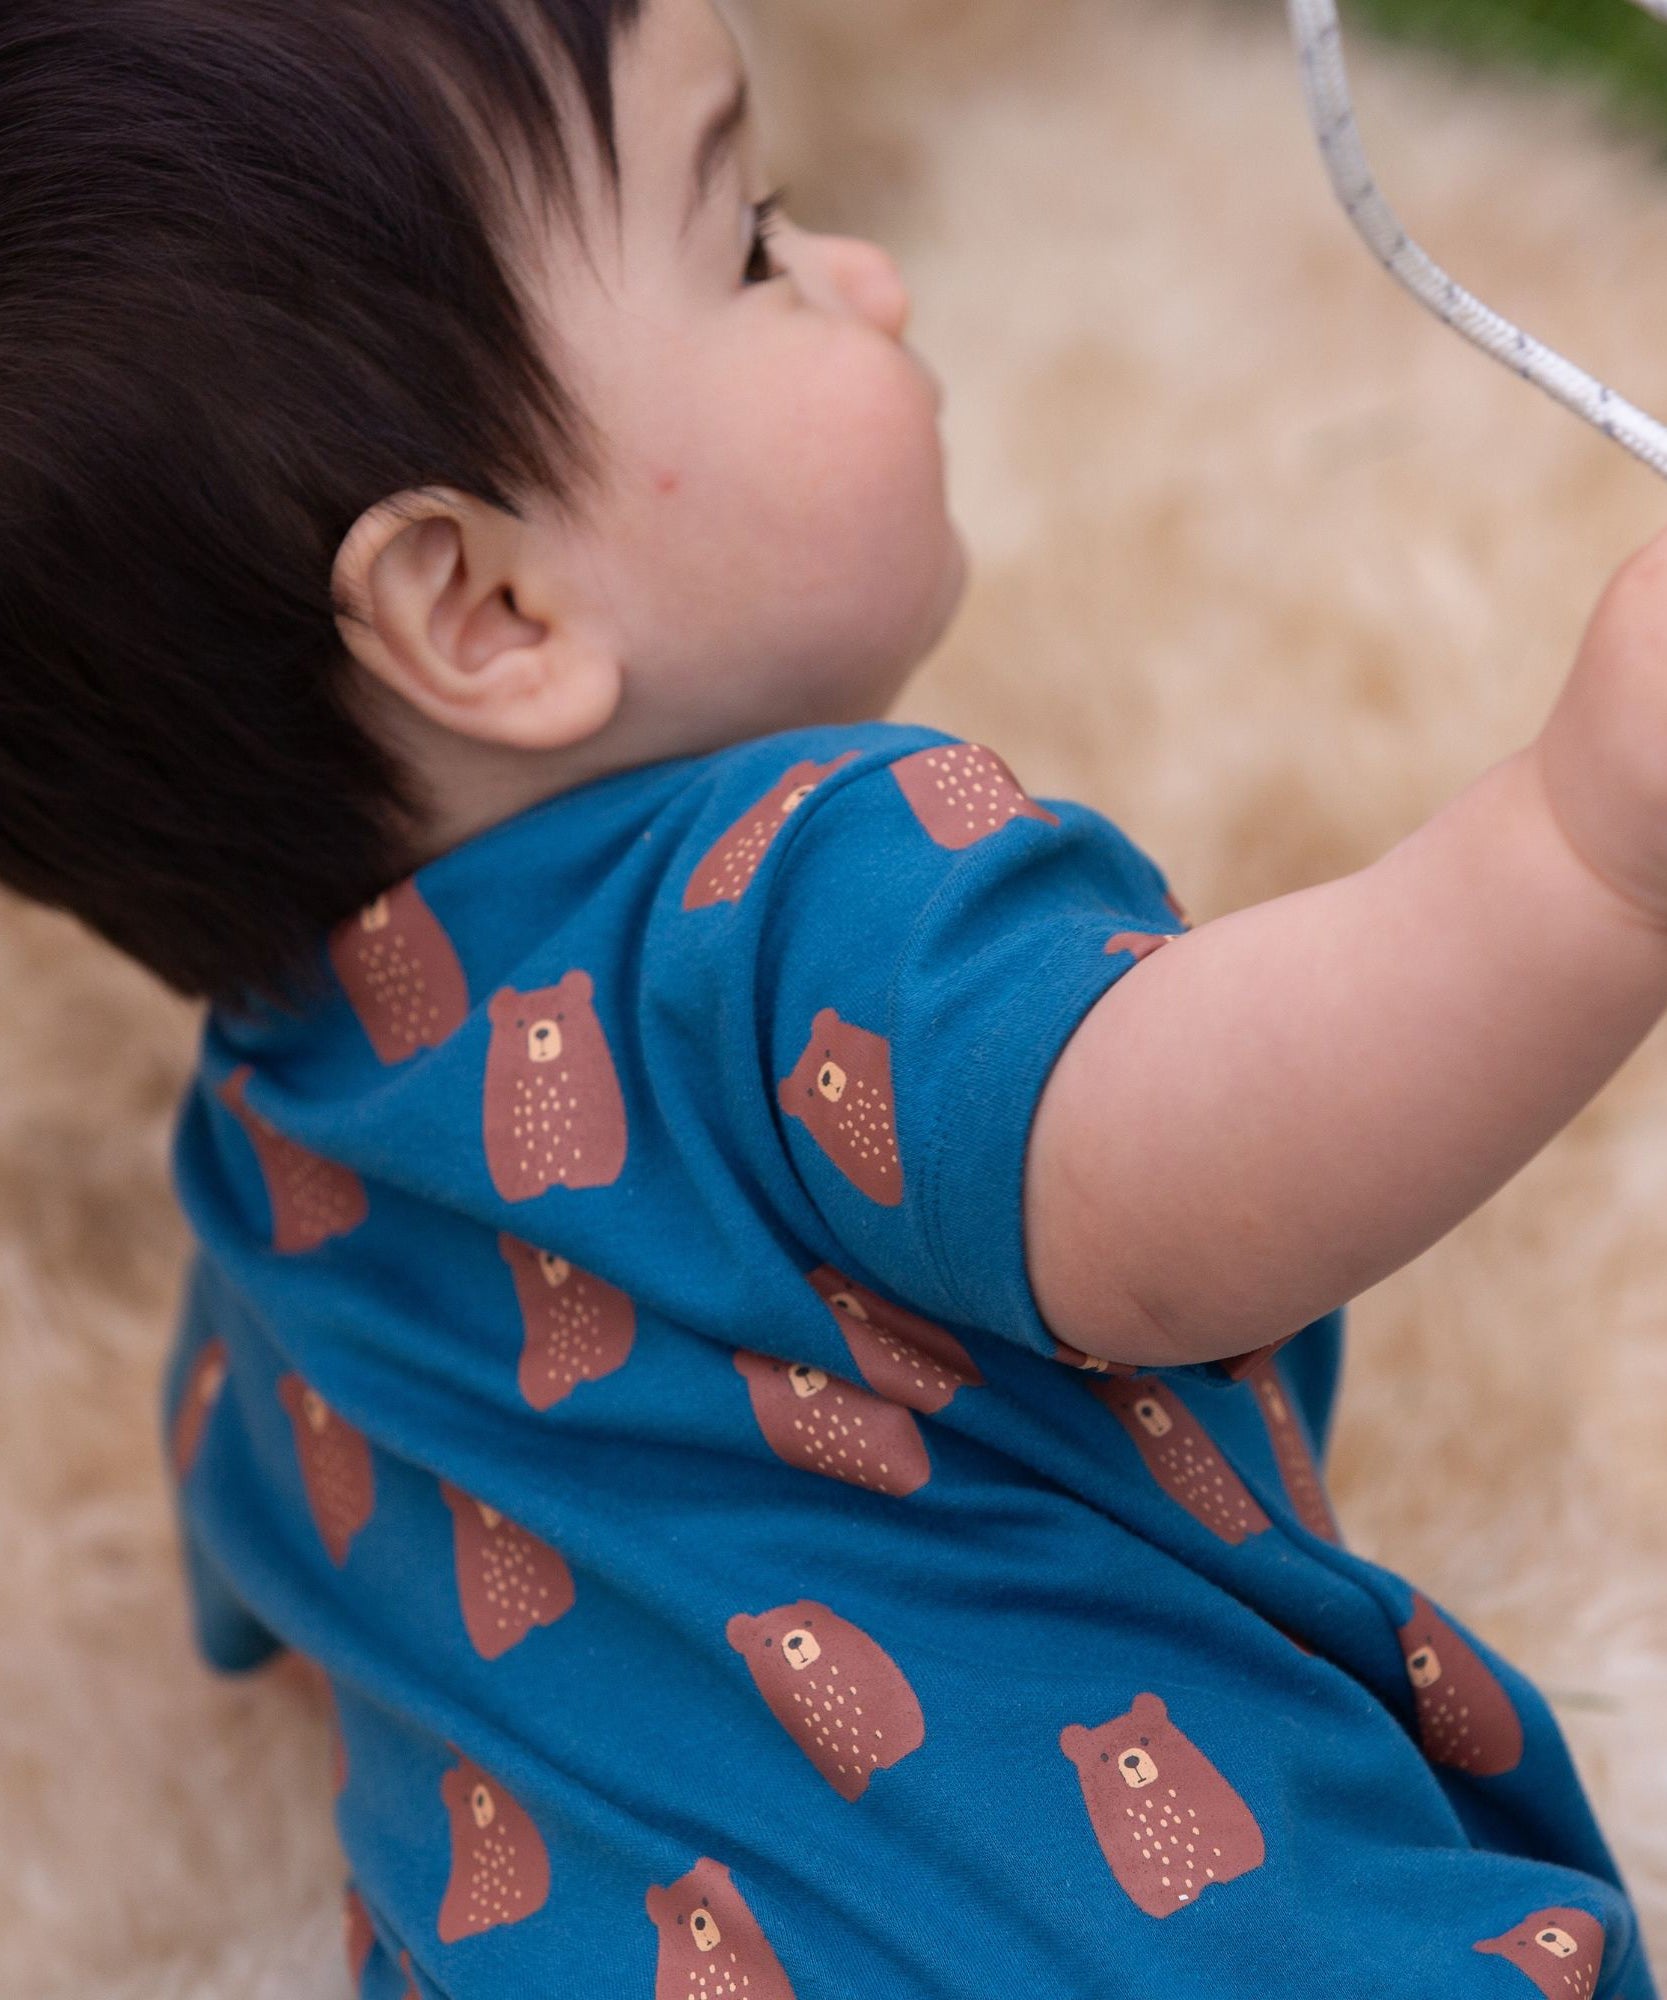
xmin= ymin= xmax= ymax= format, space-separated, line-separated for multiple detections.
xmin=162 ymin=724 xmax=1653 ymax=2000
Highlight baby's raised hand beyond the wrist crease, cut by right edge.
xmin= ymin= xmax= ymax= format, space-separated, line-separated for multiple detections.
xmin=1535 ymin=534 xmax=1667 ymax=928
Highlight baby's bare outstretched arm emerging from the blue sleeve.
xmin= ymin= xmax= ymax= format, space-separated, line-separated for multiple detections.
xmin=1025 ymin=538 xmax=1667 ymax=1366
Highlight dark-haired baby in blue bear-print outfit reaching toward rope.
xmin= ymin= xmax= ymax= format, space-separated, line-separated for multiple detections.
xmin=0 ymin=0 xmax=1667 ymax=2000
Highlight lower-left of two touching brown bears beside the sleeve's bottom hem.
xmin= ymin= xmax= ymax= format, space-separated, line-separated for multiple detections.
xmin=736 ymin=1348 xmax=931 ymax=1500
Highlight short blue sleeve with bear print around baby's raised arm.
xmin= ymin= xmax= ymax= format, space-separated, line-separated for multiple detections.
xmin=756 ymin=732 xmax=1185 ymax=1356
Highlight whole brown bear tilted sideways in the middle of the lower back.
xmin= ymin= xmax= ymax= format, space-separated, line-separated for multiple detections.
xmin=724 ymin=1600 xmax=925 ymax=1800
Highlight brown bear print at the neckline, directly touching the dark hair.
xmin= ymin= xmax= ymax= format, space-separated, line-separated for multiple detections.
xmin=330 ymin=882 xmax=470 ymax=1066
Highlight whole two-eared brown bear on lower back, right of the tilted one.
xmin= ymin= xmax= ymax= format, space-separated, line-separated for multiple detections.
xmin=1059 ymin=1694 xmax=1267 ymax=1916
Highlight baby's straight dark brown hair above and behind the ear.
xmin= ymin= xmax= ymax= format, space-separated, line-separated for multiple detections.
xmin=0 ymin=0 xmax=644 ymax=1008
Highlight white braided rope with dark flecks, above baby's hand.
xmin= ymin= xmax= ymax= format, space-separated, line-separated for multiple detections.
xmin=1287 ymin=0 xmax=1667 ymax=478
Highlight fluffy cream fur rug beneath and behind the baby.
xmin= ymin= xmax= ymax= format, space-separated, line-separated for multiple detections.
xmin=0 ymin=0 xmax=1667 ymax=2000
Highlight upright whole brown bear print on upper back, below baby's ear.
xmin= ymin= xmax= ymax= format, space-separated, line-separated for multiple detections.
xmin=486 ymin=972 xmax=626 ymax=1202
